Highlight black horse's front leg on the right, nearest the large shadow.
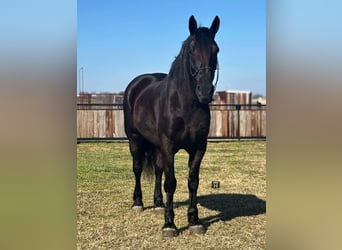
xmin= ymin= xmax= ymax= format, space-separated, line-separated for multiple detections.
xmin=188 ymin=150 xmax=205 ymax=234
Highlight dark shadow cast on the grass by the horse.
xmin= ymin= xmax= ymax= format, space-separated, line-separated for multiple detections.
xmin=174 ymin=194 xmax=266 ymax=231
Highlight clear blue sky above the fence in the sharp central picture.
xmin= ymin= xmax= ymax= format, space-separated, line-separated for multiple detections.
xmin=77 ymin=0 xmax=266 ymax=95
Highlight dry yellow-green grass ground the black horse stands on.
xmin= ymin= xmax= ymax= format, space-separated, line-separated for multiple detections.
xmin=77 ymin=141 xmax=266 ymax=249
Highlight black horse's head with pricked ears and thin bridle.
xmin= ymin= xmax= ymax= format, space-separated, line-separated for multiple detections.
xmin=189 ymin=16 xmax=220 ymax=104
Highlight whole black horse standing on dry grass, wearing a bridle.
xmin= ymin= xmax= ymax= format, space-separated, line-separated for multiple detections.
xmin=124 ymin=16 xmax=220 ymax=237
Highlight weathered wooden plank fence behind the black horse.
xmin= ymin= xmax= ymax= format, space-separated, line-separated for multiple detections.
xmin=77 ymin=104 xmax=266 ymax=140
